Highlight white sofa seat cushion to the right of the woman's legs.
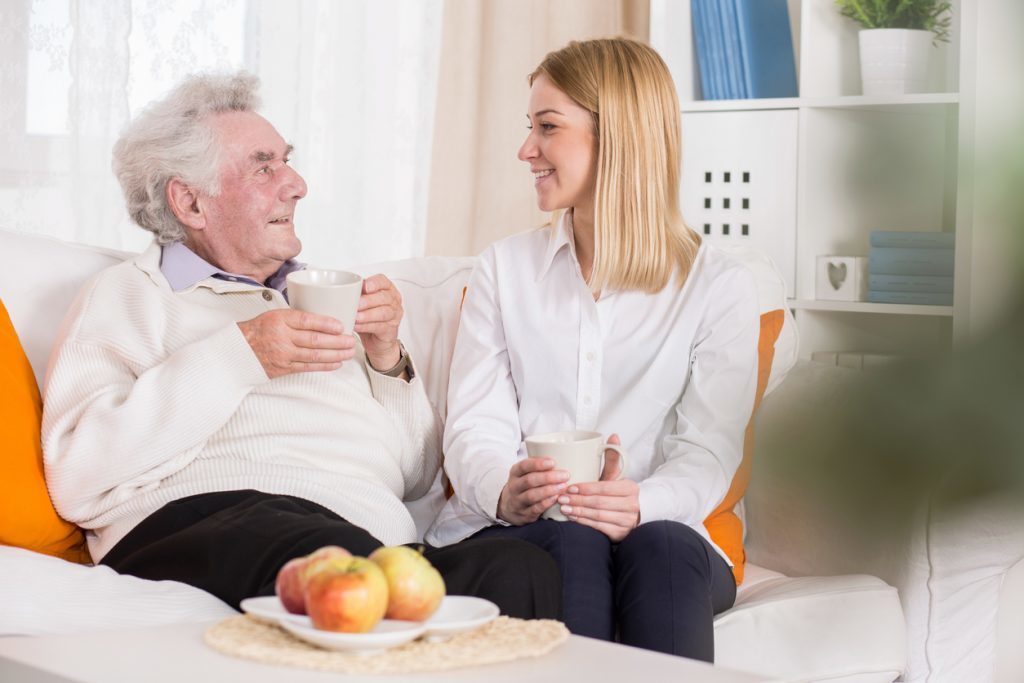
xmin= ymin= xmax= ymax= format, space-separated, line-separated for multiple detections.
xmin=715 ymin=563 xmax=906 ymax=683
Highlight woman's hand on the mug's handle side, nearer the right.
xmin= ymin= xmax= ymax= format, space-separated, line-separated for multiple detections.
xmin=558 ymin=479 xmax=640 ymax=543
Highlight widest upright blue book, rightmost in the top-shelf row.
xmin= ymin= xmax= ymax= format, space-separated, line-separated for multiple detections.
xmin=733 ymin=0 xmax=798 ymax=97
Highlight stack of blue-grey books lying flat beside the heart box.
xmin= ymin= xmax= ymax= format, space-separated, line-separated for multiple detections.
xmin=867 ymin=230 xmax=955 ymax=306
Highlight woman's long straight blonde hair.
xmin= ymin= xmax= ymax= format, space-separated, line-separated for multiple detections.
xmin=529 ymin=38 xmax=700 ymax=292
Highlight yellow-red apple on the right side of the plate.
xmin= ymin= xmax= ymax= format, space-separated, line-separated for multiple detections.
xmin=370 ymin=546 xmax=444 ymax=622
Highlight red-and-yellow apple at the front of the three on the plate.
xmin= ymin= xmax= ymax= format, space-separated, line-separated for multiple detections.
xmin=305 ymin=557 xmax=388 ymax=633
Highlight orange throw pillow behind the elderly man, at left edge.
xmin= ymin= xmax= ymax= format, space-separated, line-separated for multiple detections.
xmin=0 ymin=301 xmax=91 ymax=563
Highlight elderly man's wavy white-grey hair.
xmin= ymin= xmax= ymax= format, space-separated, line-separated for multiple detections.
xmin=113 ymin=72 xmax=260 ymax=245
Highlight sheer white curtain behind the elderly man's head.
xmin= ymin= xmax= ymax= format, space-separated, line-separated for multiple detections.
xmin=0 ymin=0 xmax=442 ymax=265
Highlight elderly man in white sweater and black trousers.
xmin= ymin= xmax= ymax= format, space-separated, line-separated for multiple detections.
xmin=43 ymin=74 xmax=561 ymax=617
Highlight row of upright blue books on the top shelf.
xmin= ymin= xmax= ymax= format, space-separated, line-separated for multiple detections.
xmin=690 ymin=0 xmax=797 ymax=99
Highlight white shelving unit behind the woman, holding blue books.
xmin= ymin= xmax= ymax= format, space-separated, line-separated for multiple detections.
xmin=650 ymin=0 xmax=976 ymax=357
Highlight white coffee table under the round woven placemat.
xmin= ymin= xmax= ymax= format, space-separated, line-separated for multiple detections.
xmin=0 ymin=623 xmax=772 ymax=683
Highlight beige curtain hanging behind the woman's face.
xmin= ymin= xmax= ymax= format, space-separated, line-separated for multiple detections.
xmin=426 ymin=0 xmax=647 ymax=255
